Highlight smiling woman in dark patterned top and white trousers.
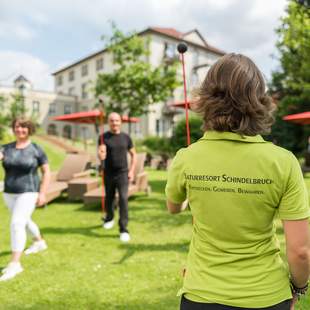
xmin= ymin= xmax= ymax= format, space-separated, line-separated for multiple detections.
xmin=0 ymin=119 xmax=50 ymax=281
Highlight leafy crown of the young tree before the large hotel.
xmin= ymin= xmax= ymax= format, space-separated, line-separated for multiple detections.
xmin=95 ymin=23 xmax=179 ymax=128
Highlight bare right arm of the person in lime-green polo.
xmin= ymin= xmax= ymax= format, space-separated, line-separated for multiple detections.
xmin=283 ymin=219 xmax=310 ymax=288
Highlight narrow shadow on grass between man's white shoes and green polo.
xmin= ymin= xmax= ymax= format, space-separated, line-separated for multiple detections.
xmin=113 ymin=242 xmax=189 ymax=265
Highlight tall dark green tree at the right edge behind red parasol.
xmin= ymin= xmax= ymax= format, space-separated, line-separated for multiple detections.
xmin=270 ymin=0 xmax=310 ymax=152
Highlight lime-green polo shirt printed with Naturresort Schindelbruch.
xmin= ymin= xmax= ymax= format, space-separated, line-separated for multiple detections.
xmin=166 ymin=131 xmax=310 ymax=308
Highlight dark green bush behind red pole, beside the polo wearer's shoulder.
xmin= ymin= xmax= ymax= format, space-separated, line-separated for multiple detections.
xmin=171 ymin=116 xmax=203 ymax=153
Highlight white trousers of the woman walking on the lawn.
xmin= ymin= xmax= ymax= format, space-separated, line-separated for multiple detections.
xmin=3 ymin=193 xmax=40 ymax=252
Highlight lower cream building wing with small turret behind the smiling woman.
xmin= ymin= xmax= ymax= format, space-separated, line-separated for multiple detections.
xmin=0 ymin=75 xmax=78 ymax=138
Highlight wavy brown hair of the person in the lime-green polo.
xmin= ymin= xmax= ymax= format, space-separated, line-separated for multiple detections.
xmin=192 ymin=53 xmax=275 ymax=136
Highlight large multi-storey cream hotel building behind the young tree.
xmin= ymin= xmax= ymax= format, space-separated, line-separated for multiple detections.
xmin=48 ymin=27 xmax=224 ymax=138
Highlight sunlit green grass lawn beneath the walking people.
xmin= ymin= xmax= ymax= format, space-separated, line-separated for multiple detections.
xmin=0 ymin=141 xmax=310 ymax=310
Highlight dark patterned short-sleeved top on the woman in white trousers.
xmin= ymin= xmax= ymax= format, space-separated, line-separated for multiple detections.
xmin=0 ymin=142 xmax=47 ymax=194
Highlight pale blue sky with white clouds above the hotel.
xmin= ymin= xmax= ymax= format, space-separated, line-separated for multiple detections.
xmin=0 ymin=0 xmax=287 ymax=91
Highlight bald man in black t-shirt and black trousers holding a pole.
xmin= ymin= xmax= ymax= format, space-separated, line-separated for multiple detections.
xmin=99 ymin=112 xmax=136 ymax=242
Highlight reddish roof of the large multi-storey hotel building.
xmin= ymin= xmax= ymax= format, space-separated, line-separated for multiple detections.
xmin=52 ymin=27 xmax=226 ymax=75
